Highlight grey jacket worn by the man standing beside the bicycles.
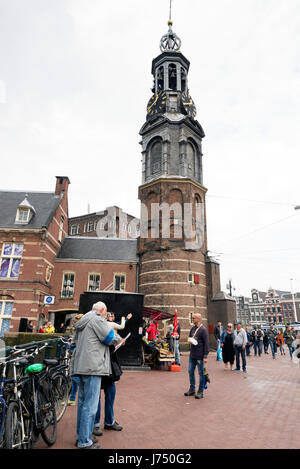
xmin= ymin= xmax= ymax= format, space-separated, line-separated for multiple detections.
xmin=70 ymin=311 xmax=121 ymax=376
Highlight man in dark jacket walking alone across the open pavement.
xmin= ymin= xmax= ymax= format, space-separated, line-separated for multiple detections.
xmin=184 ymin=313 xmax=209 ymax=399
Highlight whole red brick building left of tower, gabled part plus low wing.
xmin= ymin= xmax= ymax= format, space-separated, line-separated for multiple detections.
xmin=0 ymin=177 xmax=138 ymax=337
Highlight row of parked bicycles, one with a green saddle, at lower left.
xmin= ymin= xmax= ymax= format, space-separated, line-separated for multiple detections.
xmin=0 ymin=337 xmax=71 ymax=449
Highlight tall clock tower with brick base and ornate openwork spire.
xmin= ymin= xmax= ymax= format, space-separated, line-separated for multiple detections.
xmin=139 ymin=20 xmax=211 ymax=340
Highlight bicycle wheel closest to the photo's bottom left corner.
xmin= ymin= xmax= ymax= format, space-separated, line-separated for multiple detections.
xmin=4 ymin=401 xmax=26 ymax=449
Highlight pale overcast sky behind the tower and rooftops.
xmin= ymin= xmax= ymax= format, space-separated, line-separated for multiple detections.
xmin=0 ymin=0 xmax=300 ymax=296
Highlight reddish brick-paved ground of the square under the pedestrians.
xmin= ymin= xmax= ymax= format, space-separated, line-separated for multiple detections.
xmin=39 ymin=351 xmax=300 ymax=449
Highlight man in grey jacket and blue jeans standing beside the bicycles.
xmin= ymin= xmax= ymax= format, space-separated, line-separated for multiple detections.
xmin=70 ymin=302 xmax=125 ymax=449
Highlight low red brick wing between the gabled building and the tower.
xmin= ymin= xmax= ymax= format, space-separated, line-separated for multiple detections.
xmin=49 ymin=237 xmax=138 ymax=326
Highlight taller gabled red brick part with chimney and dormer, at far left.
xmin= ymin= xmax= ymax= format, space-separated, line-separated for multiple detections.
xmin=0 ymin=177 xmax=70 ymax=336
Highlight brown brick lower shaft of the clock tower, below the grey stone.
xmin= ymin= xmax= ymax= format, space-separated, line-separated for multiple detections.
xmin=139 ymin=178 xmax=208 ymax=342
